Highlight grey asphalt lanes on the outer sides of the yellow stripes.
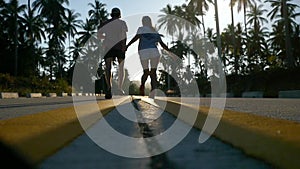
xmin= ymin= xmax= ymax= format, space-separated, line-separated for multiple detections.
xmin=0 ymin=96 xmax=300 ymax=122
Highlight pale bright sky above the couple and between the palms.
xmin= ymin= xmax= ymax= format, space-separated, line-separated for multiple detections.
xmin=15 ymin=0 xmax=300 ymax=79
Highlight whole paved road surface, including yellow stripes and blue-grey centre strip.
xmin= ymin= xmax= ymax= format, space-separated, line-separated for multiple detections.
xmin=0 ymin=97 xmax=300 ymax=169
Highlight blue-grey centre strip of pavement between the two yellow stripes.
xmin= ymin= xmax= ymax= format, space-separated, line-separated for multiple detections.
xmin=40 ymin=101 xmax=271 ymax=169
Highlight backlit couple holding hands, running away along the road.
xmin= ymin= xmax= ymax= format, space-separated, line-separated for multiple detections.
xmin=98 ymin=8 xmax=173 ymax=99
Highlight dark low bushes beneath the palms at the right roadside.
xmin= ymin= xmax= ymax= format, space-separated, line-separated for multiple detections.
xmin=227 ymin=67 xmax=300 ymax=97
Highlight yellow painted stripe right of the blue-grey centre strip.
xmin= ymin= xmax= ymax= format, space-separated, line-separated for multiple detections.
xmin=155 ymin=99 xmax=300 ymax=169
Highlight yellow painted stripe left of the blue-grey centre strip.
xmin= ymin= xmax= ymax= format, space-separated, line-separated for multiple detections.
xmin=0 ymin=97 xmax=129 ymax=165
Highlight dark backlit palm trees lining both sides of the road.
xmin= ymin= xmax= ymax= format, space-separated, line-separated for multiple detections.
xmin=0 ymin=0 xmax=300 ymax=95
